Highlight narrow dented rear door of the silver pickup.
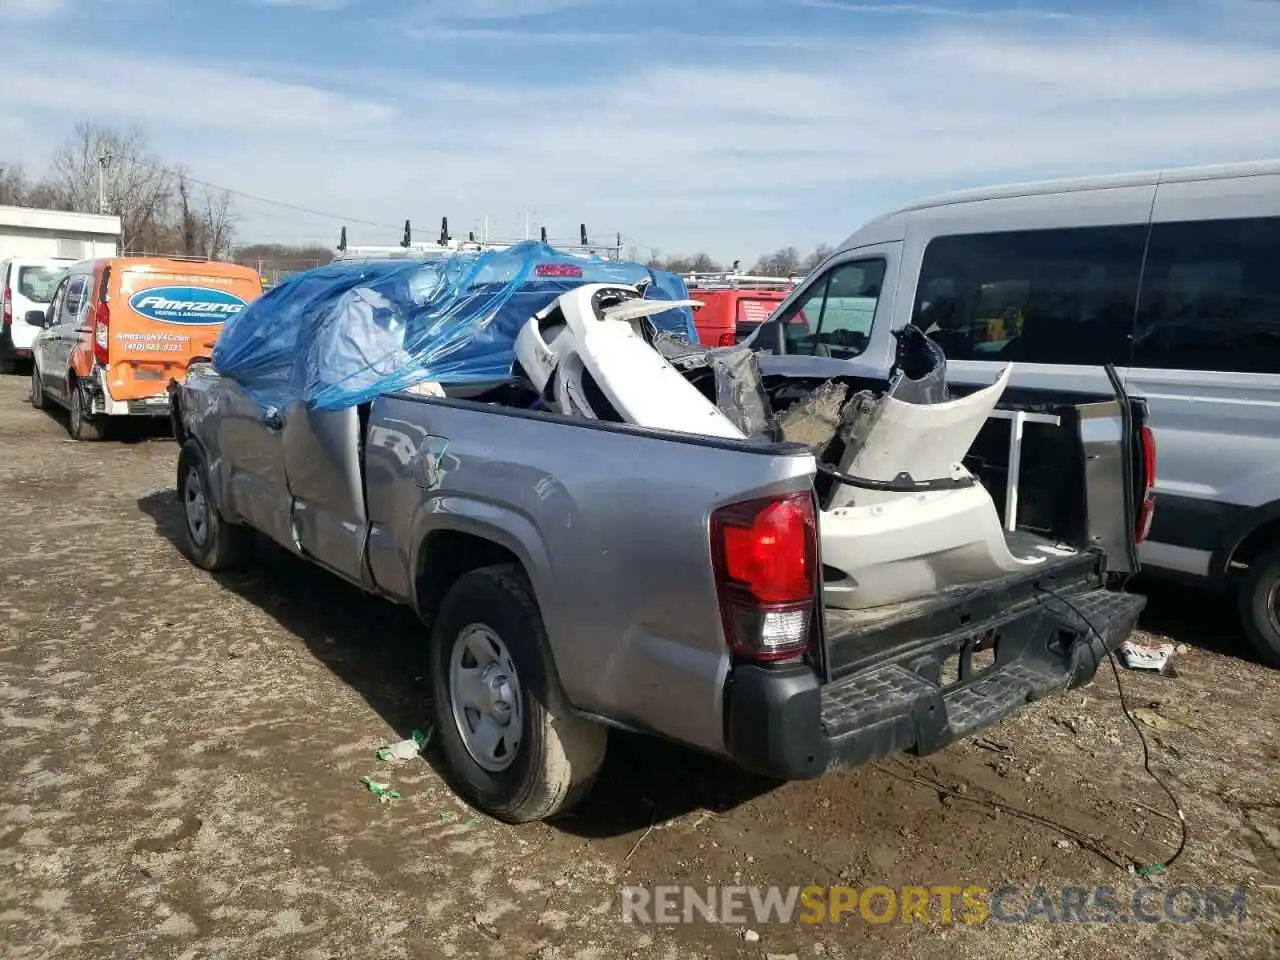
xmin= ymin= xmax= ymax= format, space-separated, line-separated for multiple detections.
xmin=282 ymin=403 xmax=369 ymax=582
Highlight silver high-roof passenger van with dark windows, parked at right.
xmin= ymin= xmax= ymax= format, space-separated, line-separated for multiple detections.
xmin=752 ymin=161 xmax=1280 ymax=666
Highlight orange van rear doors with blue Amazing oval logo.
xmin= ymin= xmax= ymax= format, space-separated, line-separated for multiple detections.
xmin=112 ymin=270 xmax=259 ymax=401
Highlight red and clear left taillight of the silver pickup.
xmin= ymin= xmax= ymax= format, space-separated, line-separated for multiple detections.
xmin=710 ymin=492 xmax=819 ymax=662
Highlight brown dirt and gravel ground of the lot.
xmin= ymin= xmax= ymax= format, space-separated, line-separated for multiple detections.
xmin=0 ymin=376 xmax=1280 ymax=960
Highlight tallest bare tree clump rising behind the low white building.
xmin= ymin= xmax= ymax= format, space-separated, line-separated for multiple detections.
xmin=50 ymin=123 xmax=174 ymax=251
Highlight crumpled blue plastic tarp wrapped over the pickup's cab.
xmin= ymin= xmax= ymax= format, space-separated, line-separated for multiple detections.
xmin=212 ymin=241 xmax=698 ymax=410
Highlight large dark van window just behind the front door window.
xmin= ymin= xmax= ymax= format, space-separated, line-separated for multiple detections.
xmin=911 ymin=225 xmax=1147 ymax=366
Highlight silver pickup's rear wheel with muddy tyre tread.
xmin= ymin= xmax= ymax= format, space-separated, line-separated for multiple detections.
xmin=431 ymin=564 xmax=608 ymax=823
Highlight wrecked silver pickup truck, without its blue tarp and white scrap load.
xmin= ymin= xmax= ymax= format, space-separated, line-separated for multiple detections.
xmin=172 ymin=276 xmax=1155 ymax=823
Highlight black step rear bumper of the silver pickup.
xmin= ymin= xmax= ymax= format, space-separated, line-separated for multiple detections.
xmin=726 ymin=563 xmax=1147 ymax=780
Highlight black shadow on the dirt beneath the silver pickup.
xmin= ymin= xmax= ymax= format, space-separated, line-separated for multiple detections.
xmin=138 ymin=492 xmax=777 ymax=838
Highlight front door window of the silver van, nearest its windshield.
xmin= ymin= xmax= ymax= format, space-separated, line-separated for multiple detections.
xmin=778 ymin=257 xmax=886 ymax=357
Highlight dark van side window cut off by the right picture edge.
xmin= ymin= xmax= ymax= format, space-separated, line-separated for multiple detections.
xmin=1133 ymin=218 xmax=1280 ymax=374
